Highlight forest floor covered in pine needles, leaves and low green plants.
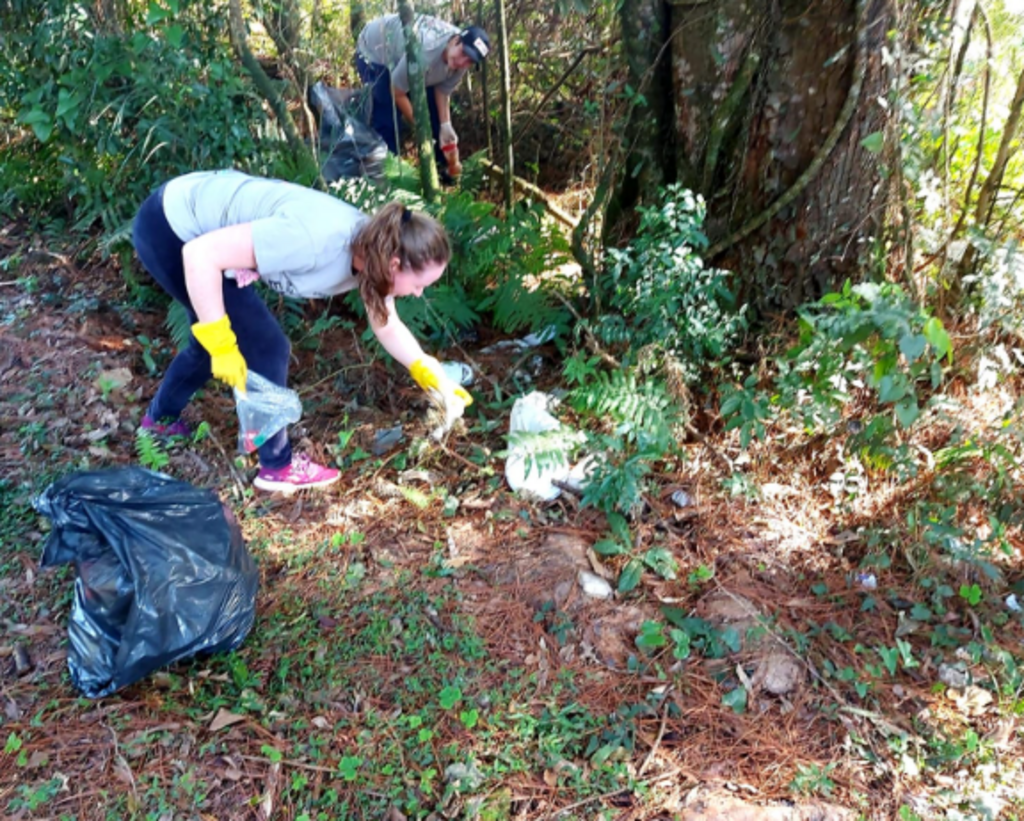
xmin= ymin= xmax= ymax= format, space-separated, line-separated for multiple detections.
xmin=0 ymin=219 xmax=1024 ymax=821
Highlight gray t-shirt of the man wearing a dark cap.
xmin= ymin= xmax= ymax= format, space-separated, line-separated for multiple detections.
xmin=355 ymin=14 xmax=467 ymax=94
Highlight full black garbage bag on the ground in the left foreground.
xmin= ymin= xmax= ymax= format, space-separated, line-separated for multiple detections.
xmin=35 ymin=468 xmax=259 ymax=698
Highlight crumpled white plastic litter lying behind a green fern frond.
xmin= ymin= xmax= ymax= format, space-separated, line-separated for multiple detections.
xmin=505 ymin=391 xmax=580 ymax=502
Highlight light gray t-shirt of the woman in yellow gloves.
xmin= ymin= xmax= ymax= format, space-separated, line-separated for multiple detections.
xmin=164 ymin=170 xmax=369 ymax=299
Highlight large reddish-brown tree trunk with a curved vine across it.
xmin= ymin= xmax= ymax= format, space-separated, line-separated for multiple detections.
xmin=672 ymin=0 xmax=892 ymax=309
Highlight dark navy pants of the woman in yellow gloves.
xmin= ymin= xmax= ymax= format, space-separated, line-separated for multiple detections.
xmin=132 ymin=186 xmax=292 ymax=470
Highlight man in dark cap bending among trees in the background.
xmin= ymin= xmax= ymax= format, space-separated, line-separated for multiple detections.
xmin=355 ymin=14 xmax=490 ymax=182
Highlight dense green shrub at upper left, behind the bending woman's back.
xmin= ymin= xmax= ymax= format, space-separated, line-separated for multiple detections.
xmin=0 ymin=0 xmax=278 ymax=235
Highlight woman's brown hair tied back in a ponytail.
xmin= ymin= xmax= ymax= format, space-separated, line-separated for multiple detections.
xmin=352 ymin=202 xmax=452 ymax=325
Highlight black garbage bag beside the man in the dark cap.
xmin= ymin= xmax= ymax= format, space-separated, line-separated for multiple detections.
xmin=308 ymin=82 xmax=387 ymax=182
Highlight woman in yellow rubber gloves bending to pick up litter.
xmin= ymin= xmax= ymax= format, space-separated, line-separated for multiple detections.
xmin=132 ymin=170 xmax=472 ymax=490
